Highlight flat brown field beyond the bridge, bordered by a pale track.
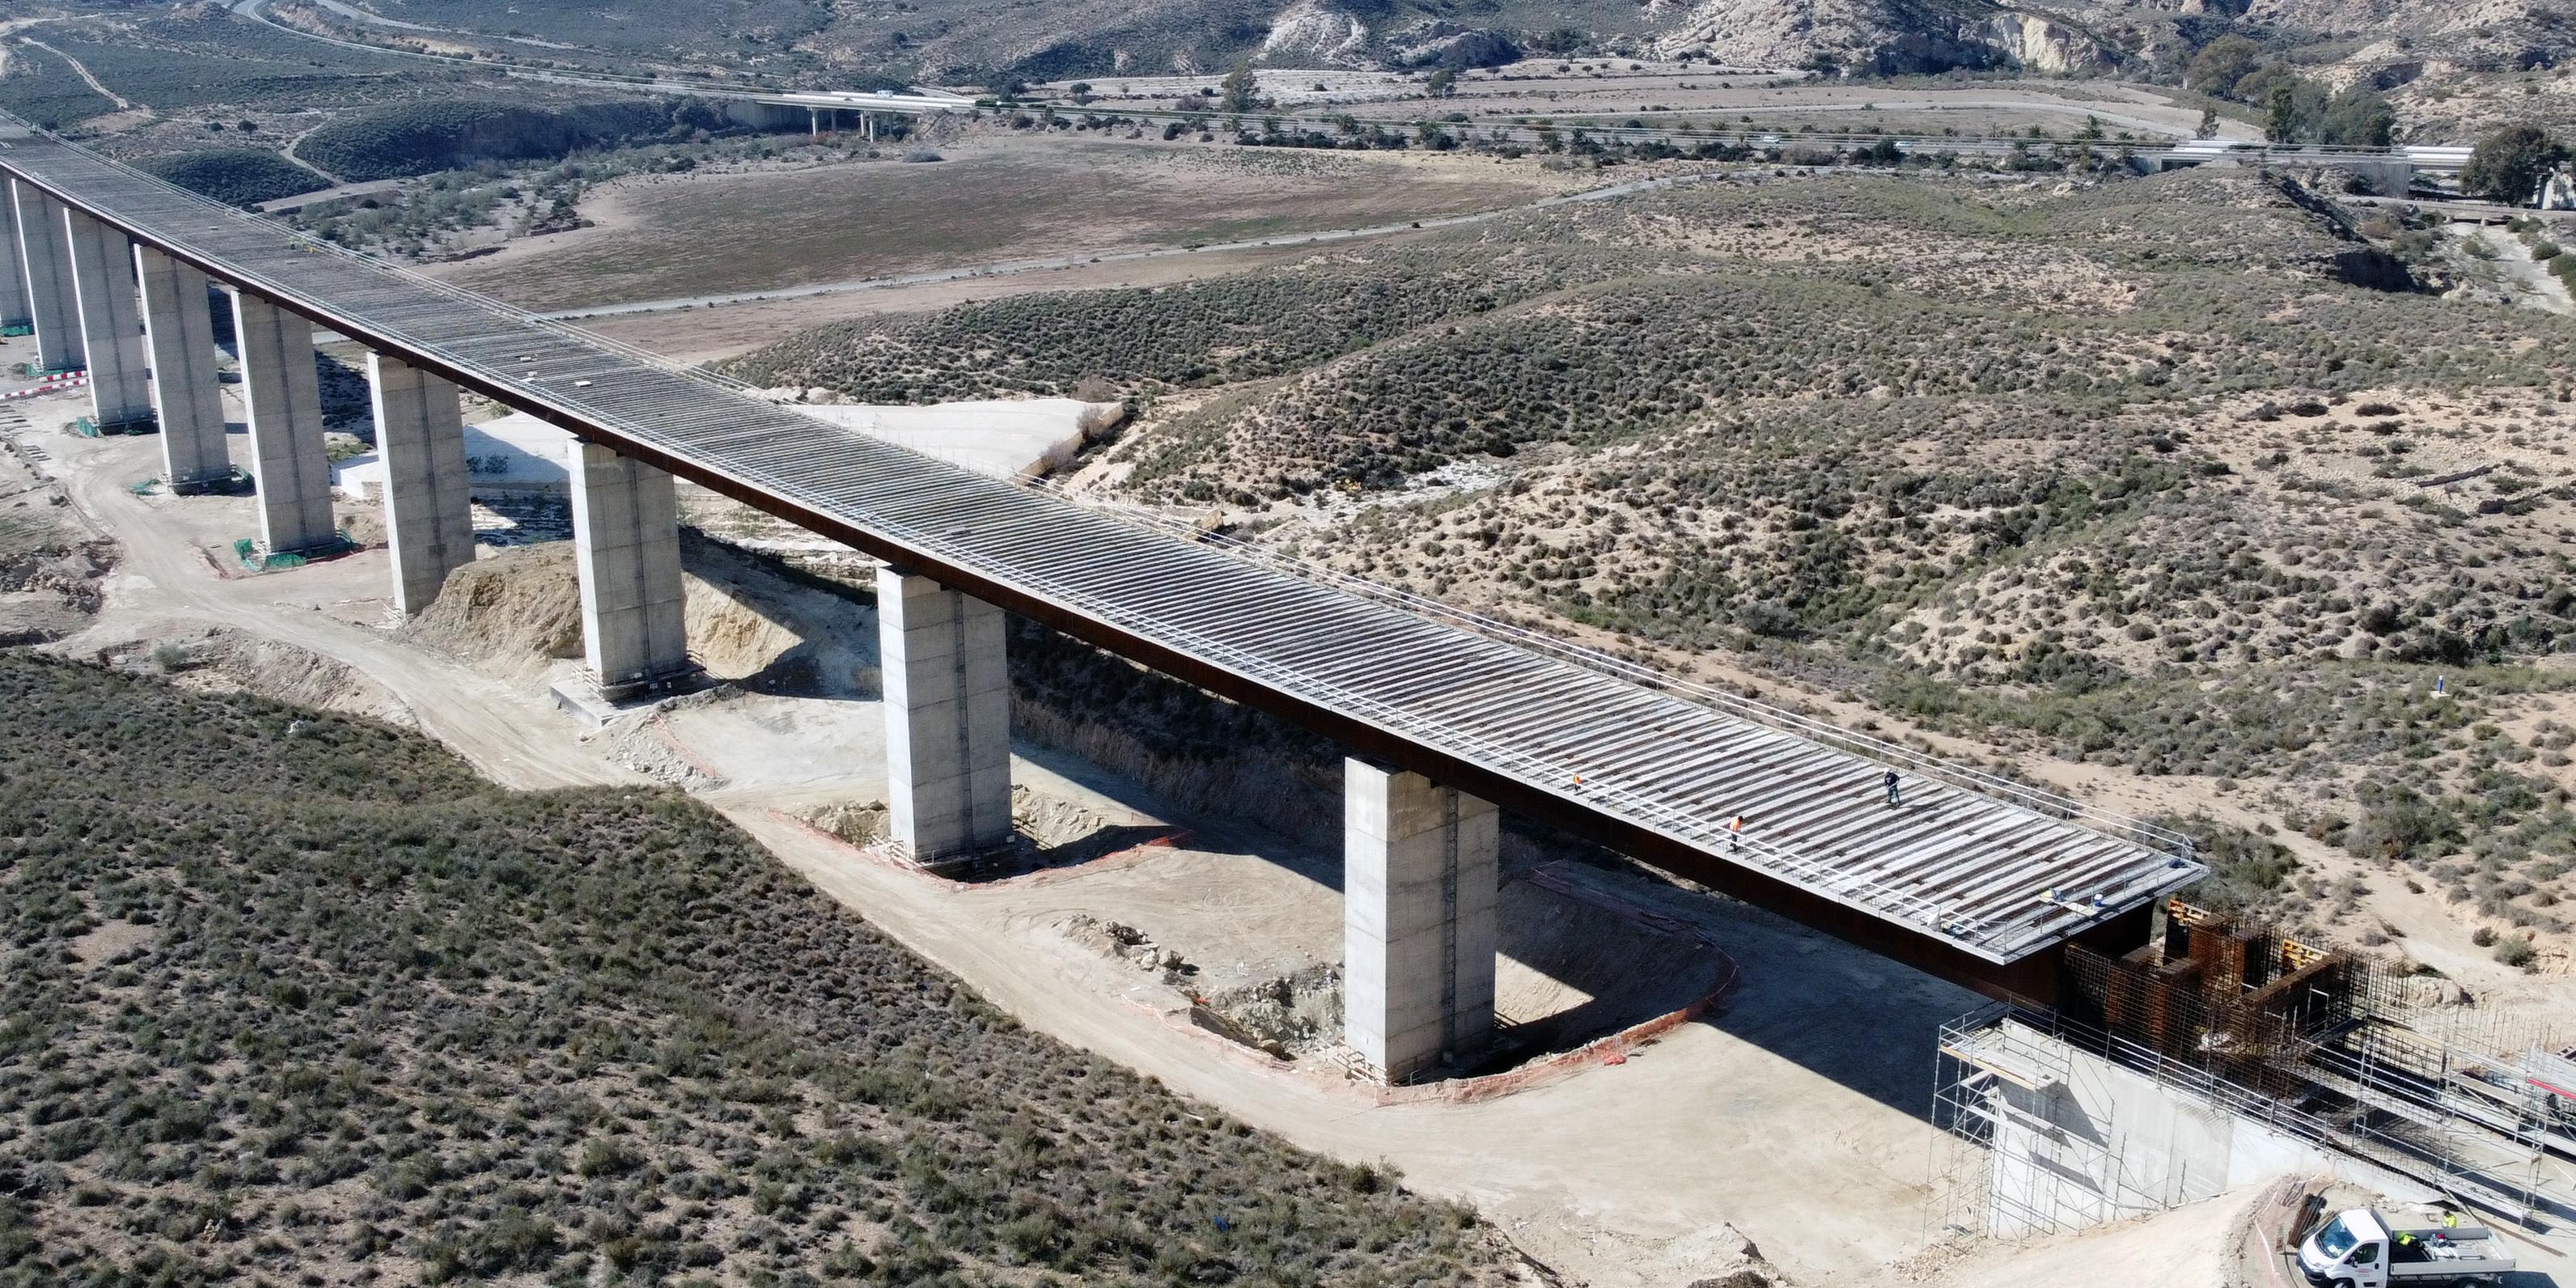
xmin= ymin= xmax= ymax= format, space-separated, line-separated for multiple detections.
xmin=435 ymin=131 xmax=1574 ymax=309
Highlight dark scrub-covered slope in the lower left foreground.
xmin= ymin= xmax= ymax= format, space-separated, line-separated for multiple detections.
xmin=0 ymin=655 xmax=1507 ymax=1286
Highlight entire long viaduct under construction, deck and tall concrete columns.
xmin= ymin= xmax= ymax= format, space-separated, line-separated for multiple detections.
xmin=0 ymin=116 xmax=2205 ymax=1079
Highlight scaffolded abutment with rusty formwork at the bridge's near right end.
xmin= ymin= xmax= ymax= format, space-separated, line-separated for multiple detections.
xmin=1927 ymin=901 xmax=2576 ymax=1236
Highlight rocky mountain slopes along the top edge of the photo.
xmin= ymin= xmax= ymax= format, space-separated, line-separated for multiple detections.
xmin=242 ymin=0 xmax=2576 ymax=90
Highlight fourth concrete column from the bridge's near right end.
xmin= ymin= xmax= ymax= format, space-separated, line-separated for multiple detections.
xmin=366 ymin=353 xmax=474 ymax=613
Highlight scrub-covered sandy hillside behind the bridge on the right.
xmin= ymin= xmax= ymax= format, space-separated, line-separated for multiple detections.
xmin=742 ymin=172 xmax=2576 ymax=968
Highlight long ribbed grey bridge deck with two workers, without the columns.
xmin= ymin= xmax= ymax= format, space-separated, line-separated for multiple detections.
xmin=0 ymin=126 xmax=2202 ymax=964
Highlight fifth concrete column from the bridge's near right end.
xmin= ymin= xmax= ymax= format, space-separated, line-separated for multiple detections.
xmin=232 ymin=291 xmax=340 ymax=554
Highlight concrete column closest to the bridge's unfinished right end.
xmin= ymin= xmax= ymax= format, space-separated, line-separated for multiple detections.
xmin=1342 ymin=760 xmax=1502 ymax=1082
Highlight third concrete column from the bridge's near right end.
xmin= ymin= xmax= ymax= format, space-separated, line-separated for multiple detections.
xmin=566 ymin=443 xmax=688 ymax=698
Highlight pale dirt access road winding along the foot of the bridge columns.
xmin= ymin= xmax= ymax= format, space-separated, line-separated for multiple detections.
xmin=31 ymin=375 xmax=1973 ymax=1288
